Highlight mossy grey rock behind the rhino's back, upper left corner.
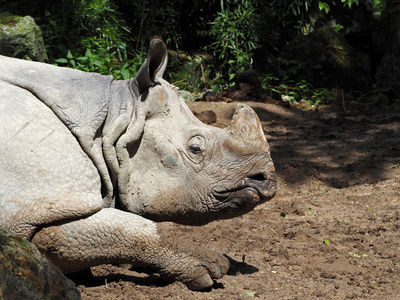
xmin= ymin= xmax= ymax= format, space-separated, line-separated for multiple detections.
xmin=0 ymin=14 xmax=46 ymax=62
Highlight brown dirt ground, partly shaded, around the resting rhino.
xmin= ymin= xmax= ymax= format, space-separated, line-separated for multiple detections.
xmin=75 ymin=102 xmax=400 ymax=299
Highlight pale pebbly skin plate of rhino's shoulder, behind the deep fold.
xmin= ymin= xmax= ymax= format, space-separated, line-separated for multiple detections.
xmin=0 ymin=81 xmax=102 ymax=239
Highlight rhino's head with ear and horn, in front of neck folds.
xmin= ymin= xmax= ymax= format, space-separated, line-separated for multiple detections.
xmin=118 ymin=40 xmax=276 ymax=225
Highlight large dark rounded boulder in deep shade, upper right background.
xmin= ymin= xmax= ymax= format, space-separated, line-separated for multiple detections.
xmin=271 ymin=27 xmax=372 ymax=90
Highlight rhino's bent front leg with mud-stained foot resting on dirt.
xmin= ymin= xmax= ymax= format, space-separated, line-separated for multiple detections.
xmin=32 ymin=208 xmax=229 ymax=290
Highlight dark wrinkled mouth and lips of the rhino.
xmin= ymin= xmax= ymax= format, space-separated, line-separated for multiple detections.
xmin=213 ymin=174 xmax=276 ymax=213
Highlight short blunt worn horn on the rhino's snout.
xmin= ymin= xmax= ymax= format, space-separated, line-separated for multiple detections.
xmin=228 ymin=104 xmax=269 ymax=149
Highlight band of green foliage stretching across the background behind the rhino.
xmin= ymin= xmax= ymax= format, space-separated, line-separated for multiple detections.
xmin=0 ymin=0 xmax=388 ymax=103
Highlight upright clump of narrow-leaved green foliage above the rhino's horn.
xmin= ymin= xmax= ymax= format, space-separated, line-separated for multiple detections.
xmin=210 ymin=0 xmax=259 ymax=81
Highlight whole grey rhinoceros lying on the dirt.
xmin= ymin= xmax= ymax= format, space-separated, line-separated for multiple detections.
xmin=0 ymin=39 xmax=276 ymax=290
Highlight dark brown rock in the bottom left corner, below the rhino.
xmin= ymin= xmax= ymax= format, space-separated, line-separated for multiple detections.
xmin=0 ymin=228 xmax=81 ymax=300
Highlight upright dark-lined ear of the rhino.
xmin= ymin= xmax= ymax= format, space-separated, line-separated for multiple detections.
xmin=132 ymin=38 xmax=168 ymax=95
